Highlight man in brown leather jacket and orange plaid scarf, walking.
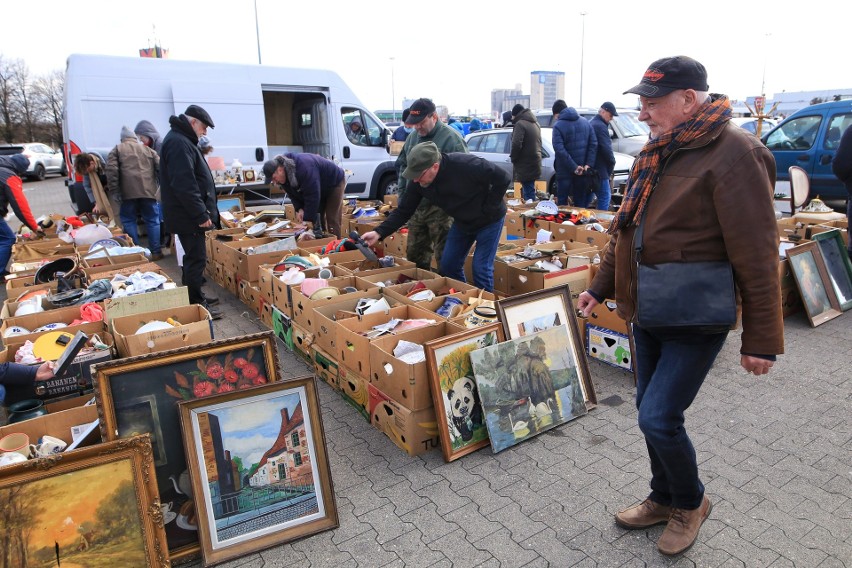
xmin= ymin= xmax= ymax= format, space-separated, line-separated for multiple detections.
xmin=578 ymin=56 xmax=784 ymax=555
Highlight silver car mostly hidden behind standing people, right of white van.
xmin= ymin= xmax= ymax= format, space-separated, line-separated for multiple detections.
xmin=465 ymin=128 xmax=634 ymax=202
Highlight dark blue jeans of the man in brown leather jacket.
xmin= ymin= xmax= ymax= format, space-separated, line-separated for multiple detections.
xmin=633 ymin=325 xmax=728 ymax=509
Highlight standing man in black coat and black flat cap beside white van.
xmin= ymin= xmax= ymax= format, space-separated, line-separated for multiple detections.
xmin=160 ymin=105 xmax=222 ymax=319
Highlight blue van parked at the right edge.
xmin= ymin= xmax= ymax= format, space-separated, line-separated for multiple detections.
xmin=762 ymin=99 xmax=852 ymax=199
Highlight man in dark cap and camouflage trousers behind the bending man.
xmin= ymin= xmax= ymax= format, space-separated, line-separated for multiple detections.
xmin=396 ymin=99 xmax=467 ymax=270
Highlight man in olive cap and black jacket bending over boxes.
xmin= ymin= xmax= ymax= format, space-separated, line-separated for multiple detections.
xmin=362 ymin=142 xmax=512 ymax=292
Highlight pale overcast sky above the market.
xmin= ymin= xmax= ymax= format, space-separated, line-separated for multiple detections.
xmin=5 ymin=0 xmax=852 ymax=114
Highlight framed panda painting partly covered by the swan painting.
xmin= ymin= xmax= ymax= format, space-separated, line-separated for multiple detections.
xmin=424 ymin=323 xmax=503 ymax=462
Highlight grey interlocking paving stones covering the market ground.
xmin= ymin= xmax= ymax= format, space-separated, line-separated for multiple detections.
xmin=10 ymin=182 xmax=852 ymax=568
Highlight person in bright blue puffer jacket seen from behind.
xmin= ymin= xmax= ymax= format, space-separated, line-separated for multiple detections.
xmin=553 ymin=99 xmax=598 ymax=207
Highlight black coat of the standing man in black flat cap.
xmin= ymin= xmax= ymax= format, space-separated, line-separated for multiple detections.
xmin=160 ymin=115 xmax=219 ymax=235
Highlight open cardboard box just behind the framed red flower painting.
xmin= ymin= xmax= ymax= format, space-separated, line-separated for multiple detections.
xmin=111 ymin=304 xmax=213 ymax=357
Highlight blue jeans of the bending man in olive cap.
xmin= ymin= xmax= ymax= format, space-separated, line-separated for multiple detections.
xmin=440 ymin=219 xmax=503 ymax=292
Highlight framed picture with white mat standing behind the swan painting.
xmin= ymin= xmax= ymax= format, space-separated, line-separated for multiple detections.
xmin=497 ymin=286 xmax=598 ymax=409
